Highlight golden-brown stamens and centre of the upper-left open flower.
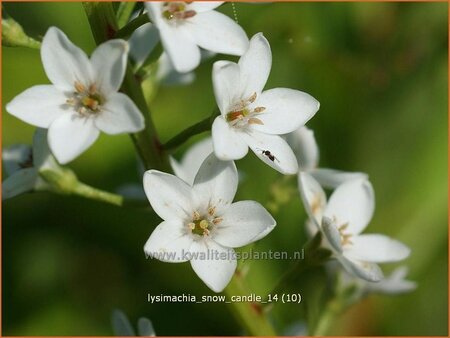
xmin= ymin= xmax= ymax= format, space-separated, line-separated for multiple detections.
xmin=66 ymin=81 xmax=104 ymax=116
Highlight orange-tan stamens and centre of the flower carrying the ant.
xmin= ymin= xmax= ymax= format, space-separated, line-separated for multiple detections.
xmin=225 ymin=93 xmax=266 ymax=128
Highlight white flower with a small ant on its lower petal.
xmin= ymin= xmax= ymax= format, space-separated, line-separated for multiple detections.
xmin=212 ymin=33 xmax=319 ymax=174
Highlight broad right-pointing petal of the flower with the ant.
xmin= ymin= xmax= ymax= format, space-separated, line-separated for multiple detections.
xmin=252 ymin=88 xmax=320 ymax=135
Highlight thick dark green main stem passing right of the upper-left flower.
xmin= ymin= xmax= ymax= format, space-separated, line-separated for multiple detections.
xmin=83 ymin=2 xmax=170 ymax=171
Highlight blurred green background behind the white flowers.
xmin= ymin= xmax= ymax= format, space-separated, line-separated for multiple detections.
xmin=2 ymin=3 xmax=448 ymax=335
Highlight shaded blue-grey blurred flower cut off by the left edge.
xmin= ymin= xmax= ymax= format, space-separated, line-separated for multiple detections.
xmin=2 ymin=129 xmax=58 ymax=200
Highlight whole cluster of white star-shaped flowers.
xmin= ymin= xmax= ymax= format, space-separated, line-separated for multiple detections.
xmin=3 ymin=1 xmax=413 ymax=292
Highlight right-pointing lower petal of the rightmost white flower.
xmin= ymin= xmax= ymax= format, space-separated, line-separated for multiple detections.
xmin=345 ymin=234 xmax=411 ymax=263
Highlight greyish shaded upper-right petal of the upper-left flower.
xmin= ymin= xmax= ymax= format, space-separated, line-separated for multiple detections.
xmin=91 ymin=39 xmax=129 ymax=93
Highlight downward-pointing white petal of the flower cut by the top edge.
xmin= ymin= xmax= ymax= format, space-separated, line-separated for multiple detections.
xmin=158 ymin=22 xmax=201 ymax=73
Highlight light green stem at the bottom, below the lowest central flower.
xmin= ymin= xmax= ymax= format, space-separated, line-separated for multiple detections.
xmin=224 ymin=270 xmax=276 ymax=336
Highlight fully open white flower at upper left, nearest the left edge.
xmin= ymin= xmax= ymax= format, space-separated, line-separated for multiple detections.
xmin=6 ymin=27 xmax=144 ymax=163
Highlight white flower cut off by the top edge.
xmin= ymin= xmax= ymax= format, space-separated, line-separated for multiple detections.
xmin=145 ymin=1 xmax=248 ymax=73
